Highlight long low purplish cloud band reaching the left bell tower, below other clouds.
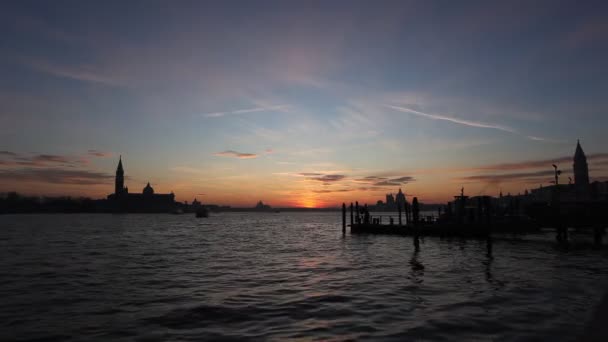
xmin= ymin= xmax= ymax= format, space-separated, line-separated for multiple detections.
xmin=0 ymin=168 xmax=114 ymax=185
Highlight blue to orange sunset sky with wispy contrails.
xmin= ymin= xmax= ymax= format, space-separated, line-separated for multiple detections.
xmin=0 ymin=0 xmax=608 ymax=207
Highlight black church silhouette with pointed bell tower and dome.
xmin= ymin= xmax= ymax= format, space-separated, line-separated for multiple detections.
xmin=108 ymin=156 xmax=177 ymax=213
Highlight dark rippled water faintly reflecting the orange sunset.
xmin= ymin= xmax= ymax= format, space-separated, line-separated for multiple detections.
xmin=0 ymin=213 xmax=608 ymax=341
